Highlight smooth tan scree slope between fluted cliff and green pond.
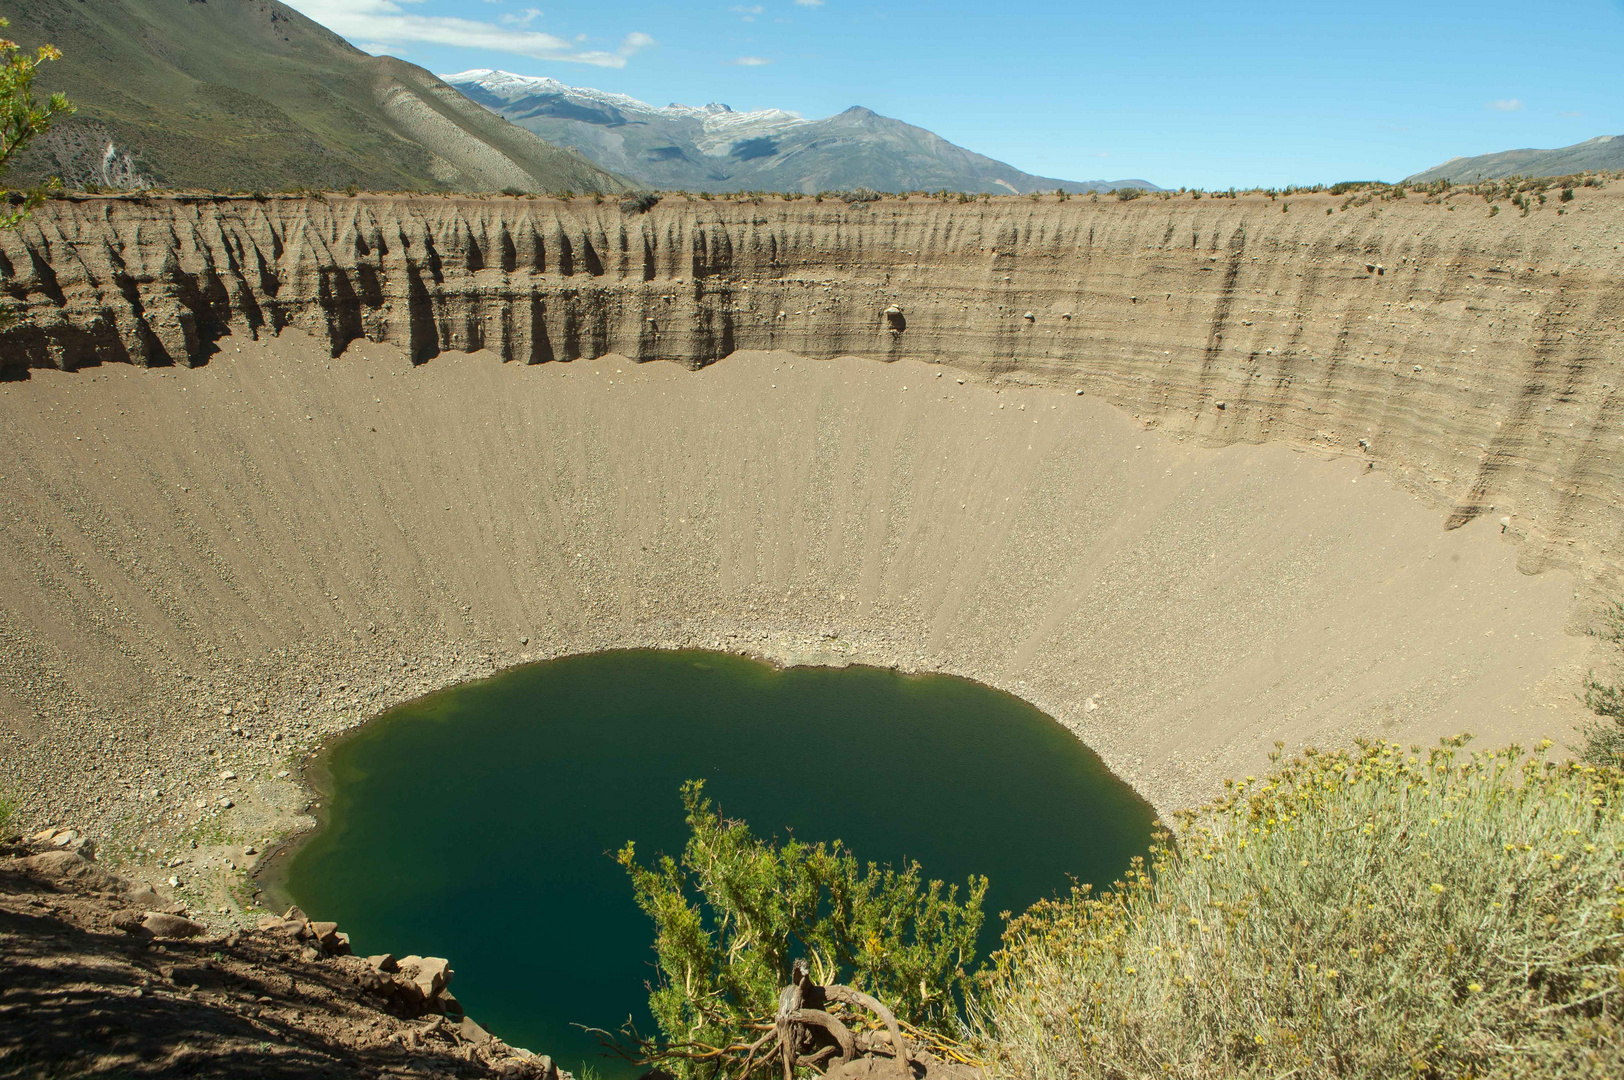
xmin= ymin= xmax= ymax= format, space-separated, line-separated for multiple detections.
xmin=0 ymin=331 xmax=1588 ymax=906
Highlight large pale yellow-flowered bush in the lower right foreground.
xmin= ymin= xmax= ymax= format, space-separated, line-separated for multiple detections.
xmin=974 ymin=739 xmax=1624 ymax=1080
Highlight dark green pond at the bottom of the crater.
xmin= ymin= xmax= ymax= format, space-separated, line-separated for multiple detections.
xmin=284 ymin=651 xmax=1153 ymax=1075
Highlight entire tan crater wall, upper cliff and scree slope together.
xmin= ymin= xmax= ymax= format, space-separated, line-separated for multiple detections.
xmin=0 ymin=190 xmax=1624 ymax=876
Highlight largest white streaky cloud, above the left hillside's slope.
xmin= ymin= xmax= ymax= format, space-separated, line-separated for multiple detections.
xmin=287 ymin=0 xmax=654 ymax=68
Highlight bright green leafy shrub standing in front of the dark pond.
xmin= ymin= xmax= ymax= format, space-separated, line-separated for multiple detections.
xmin=617 ymin=781 xmax=987 ymax=1077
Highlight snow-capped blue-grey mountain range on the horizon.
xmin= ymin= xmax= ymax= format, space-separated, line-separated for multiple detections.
xmin=440 ymin=68 xmax=1161 ymax=193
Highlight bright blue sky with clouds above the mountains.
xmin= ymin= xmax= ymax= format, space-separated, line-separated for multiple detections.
xmin=286 ymin=0 xmax=1624 ymax=188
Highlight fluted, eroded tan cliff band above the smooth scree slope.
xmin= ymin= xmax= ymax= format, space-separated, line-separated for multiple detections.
xmin=9 ymin=188 xmax=1624 ymax=586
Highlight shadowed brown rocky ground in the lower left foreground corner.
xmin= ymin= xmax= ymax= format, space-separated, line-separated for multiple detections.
xmin=0 ymin=830 xmax=568 ymax=1080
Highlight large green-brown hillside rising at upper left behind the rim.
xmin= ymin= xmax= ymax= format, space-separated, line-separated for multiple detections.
xmin=0 ymin=0 xmax=627 ymax=192
